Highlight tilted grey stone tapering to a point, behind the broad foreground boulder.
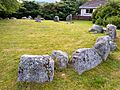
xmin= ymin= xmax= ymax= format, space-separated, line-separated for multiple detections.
xmin=93 ymin=40 xmax=110 ymax=61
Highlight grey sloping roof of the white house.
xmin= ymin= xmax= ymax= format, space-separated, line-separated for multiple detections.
xmin=79 ymin=0 xmax=107 ymax=8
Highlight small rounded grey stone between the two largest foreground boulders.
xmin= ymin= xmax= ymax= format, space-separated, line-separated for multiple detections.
xmin=51 ymin=50 xmax=68 ymax=68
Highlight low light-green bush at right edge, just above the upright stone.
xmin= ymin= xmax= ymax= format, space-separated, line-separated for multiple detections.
xmin=104 ymin=16 xmax=120 ymax=29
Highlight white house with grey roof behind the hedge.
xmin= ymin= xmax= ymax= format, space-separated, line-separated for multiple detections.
xmin=74 ymin=0 xmax=107 ymax=20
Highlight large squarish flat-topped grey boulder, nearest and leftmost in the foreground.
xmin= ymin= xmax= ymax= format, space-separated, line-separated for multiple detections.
xmin=18 ymin=55 xmax=54 ymax=83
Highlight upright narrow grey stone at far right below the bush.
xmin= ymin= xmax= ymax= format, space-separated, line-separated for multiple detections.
xmin=106 ymin=24 xmax=117 ymax=41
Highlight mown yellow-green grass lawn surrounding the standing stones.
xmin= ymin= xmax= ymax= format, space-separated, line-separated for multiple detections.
xmin=0 ymin=20 xmax=120 ymax=90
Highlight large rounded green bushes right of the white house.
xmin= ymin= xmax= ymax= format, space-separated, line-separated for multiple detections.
xmin=92 ymin=1 xmax=120 ymax=28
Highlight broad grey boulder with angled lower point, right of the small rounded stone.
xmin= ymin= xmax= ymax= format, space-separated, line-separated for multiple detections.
xmin=72 ymin=48 xmax=102 ymax=74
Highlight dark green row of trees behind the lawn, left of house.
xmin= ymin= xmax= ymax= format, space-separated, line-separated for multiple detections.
xmin=0 ymin=0 xmax=87 ymax=20
